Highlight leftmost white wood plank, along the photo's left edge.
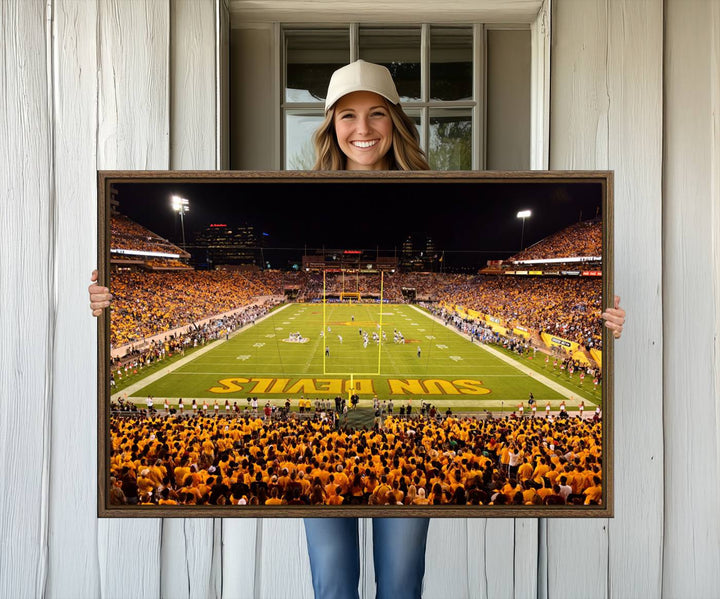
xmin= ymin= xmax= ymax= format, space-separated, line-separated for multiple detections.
xmin=0 ymin=0 xmax=55 ymax=597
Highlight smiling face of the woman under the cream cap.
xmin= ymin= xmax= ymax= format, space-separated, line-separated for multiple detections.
xmin=333 ymin=91 xmax=393 ymax=171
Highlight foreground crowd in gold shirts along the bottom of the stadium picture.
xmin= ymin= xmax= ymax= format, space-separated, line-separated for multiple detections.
xmin=110 ymin=405 xmax=602 ymax=506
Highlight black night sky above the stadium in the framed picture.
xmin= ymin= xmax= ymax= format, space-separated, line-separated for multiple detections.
xmin=114 ymin=180 xmax=602 ymax=264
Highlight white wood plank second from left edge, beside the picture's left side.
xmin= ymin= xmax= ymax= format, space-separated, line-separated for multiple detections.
xmin=47 ymin=0 xmax=100 ymax=598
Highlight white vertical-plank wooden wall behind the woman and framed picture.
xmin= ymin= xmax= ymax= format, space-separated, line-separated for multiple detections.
xmin=0 ymin=0 xmax=720 ymax=599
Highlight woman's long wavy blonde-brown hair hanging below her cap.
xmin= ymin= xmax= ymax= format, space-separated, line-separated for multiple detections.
xmin=312 ymin=102 xmax=430 ymax=171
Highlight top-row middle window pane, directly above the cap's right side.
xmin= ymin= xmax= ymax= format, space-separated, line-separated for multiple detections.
xmin=359 ymin=27 xmax=421 ymax=102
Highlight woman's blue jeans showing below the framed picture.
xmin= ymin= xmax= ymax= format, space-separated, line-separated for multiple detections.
xmin=305 ymin=518 xmax=430 ymax=599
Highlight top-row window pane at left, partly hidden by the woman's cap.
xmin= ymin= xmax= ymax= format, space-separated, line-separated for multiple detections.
xmin=284 ymin=29 xmax=350 ymax=102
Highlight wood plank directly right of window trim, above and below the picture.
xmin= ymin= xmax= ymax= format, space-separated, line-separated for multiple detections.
xmin=541 ymin=0 xmax=618 ymax=599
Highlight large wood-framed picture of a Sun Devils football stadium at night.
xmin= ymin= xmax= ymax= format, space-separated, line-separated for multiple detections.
xmin=98 ymin=171 xmax=613 ymax=518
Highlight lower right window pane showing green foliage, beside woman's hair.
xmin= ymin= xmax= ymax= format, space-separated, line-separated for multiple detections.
xmin=428 ymin=109 xmax=472 ymax=171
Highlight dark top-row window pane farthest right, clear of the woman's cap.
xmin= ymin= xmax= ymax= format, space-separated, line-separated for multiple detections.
xmin=430 ymin=27 xmax=473 ymax=101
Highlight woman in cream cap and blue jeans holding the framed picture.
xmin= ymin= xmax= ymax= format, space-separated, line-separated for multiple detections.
xmin=88 ymin=60 xmax=625 ymax=599
